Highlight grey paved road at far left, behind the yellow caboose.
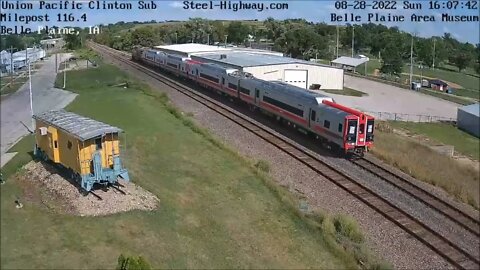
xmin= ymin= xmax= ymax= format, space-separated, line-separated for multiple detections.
xmin=0 ymin=54 xmax=76 ymax=166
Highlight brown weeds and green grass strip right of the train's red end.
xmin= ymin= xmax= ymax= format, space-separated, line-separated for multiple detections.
xmin=372 ymin=121 xmax=480 ymax=209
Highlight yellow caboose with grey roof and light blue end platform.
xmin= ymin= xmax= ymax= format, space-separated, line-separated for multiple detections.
xmin=33 ymin=110 xmax=130 ymax=192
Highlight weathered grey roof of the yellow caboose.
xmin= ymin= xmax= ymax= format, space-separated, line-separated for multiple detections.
xmin=33 ymin=110 xmax=122 ymax=141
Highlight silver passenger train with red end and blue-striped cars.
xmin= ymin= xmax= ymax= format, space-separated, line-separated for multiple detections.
xmin=132 ymin=48 xmax=374 ymax=155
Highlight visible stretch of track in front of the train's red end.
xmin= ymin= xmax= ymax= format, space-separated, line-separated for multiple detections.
xmin=351 ymin=158 xmax=480 ymax=237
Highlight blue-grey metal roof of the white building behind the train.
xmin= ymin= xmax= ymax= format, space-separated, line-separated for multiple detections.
xmin=195 ymin=51 xmax=328 ymax=68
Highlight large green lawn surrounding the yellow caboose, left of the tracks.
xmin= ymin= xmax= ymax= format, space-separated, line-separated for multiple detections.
xmin=0 ymin=60 xmax=386 ymax=269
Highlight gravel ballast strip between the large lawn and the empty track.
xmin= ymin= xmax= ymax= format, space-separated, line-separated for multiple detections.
xmin=100 ymin=56 xmax=452 ymax=269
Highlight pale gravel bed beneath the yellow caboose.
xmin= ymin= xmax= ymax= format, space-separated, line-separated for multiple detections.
xmin=16 ymin=161 xmax=160 ymax=216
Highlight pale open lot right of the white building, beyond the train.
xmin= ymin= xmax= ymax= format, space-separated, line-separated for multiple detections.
xmin=322 ymin=75 xmax=461 ymax=121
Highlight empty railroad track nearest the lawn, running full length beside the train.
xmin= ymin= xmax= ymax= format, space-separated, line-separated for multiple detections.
xmin=89 ymin=43 xmax=480 ymax=269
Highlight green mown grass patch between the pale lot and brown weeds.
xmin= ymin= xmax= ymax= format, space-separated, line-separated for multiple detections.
xmin=389 ymin=121 xmax=480 ymax=160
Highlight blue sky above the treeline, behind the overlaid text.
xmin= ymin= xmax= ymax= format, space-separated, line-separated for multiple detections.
xmin=1 ymin=0 xmax=480 ymax=44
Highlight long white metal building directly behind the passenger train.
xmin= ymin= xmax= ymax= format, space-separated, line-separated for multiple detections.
xmin=155 ymin=43 xmax=344 ymax=90
